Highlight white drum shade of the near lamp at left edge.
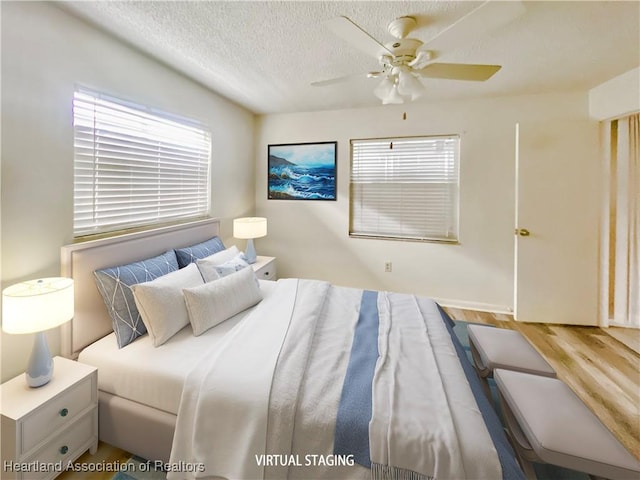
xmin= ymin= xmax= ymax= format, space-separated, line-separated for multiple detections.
xmin=2 ymin=277 xmax=74 ymax=333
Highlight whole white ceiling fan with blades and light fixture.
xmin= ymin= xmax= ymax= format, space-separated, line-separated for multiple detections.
xmin=311 ymin=1 xmax=524 ymax=104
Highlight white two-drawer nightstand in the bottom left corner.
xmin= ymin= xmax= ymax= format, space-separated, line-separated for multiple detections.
xmin=0 ymin=357 xmax=98 ymax=480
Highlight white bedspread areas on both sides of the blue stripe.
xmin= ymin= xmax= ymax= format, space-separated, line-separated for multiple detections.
xmin=167 ymin=279 xmax=501 ymax=480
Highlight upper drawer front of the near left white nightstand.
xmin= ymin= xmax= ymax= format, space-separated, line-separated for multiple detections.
xmin=19 ymin=375 xmax=95 ymax=455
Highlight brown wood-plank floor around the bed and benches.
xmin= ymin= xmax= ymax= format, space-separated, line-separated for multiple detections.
xmin=58 ymin=308 xmax=640 ymax=480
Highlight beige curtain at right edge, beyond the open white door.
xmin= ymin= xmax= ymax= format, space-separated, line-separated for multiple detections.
xmin=600 ymin=114 xmax=640 ymax=328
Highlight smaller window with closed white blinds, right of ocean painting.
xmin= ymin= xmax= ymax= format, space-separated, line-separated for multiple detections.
xmin=349 ymin=135 xmax=460 ymax=242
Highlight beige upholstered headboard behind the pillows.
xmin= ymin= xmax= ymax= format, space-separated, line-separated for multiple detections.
xmin=60 ymin=219 xmax=220 ymax=358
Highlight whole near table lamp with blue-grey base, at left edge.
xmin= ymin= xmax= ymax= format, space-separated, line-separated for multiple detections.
xmin=2 ymin=277 xmax=74 ymax=387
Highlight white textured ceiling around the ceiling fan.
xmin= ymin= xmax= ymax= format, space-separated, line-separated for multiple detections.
xmin=62 ymin=1 xmax=640 ymax=113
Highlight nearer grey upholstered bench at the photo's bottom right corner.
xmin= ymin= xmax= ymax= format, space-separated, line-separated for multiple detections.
xmin=493 ymin=369 xmax=640 ymax=480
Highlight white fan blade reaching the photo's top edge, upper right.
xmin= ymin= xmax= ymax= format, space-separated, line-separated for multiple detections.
xmin=425 ymin=0 xmax=526 ymax=51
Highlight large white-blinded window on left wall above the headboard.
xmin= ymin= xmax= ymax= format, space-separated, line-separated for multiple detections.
xmin=73 ymin=90 xmax=211 ymax=236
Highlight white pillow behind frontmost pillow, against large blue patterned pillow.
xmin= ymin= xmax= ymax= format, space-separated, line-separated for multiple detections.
xmin=131 ymin=263 xmax=204 ymax=347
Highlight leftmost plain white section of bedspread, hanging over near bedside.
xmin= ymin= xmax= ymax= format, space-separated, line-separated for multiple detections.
xmin=167 ymin=280 xmax=298 ymax=480
